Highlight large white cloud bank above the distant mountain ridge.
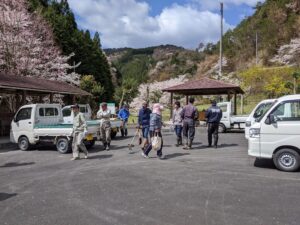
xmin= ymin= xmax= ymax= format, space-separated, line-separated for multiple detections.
xmin=69 ymin=0 xmax=234 ymax=48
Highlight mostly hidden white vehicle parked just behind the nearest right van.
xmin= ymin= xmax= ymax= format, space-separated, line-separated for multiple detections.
xmin=245 ymin=99 xmax=275 ymax=139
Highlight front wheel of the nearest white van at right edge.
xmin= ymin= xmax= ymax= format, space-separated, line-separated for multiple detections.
xmin=273 ymin=148 xmax=300 ymax=172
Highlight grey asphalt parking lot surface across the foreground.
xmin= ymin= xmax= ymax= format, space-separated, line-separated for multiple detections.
xmin=0 ymin=128 xmax=300 ymax=225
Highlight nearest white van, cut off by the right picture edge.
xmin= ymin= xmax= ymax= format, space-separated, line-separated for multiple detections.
xmin=248 ymin=95 xmax=300 ymax=172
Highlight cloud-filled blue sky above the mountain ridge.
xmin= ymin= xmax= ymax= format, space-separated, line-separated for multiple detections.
xmin=69 ymin=0 xmax=258 ymax=49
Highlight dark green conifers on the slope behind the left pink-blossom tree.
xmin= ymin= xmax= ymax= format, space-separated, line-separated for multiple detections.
xmin=28 ymin=0 xmax=114 ymax=101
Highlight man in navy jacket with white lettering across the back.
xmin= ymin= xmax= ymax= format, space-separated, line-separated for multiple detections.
xmin=205 ymin=100 xmax=222 ymax=148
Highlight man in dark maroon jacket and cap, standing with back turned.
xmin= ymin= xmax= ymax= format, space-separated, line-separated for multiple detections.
xmin=180 ymin=97 xmax=198 ymax=150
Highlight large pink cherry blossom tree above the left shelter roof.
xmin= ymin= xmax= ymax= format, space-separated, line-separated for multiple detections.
xmin=0 ymin=0 xmax=79 ymax=85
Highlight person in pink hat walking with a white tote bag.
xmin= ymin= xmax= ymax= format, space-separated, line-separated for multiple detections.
xmin=142 ymin=103 xmax=164 ymax=159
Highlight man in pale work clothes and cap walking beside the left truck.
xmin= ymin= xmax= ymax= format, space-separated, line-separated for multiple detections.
xmin=71 ymin=104 xmax=88 ymax=160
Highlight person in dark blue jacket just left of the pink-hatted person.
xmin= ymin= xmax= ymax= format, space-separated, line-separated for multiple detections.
xmin=138 ymin=102 xmax=152 ymax=150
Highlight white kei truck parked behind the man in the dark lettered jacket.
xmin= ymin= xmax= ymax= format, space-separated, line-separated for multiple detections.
xmin=217 ymin=102 xmax=248 ymax=133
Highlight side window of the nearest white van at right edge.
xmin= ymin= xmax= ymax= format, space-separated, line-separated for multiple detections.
xmin=272 ymin=101 xmax=300 ymax=121
